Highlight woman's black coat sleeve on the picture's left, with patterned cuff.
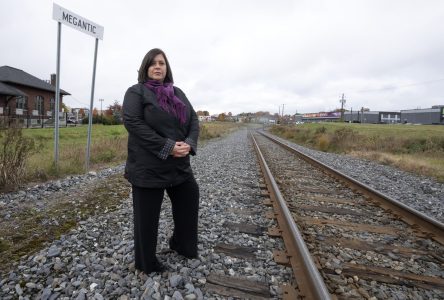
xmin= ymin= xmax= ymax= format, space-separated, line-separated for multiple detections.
xmin=123 ymin=86 xmax=176 ymax=159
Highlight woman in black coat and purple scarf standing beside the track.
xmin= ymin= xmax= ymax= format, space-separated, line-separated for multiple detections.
xmin=123 ymin=48 xmax=199 ymax=274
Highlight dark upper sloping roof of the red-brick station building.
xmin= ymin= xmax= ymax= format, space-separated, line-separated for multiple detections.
xmin=0 ymin=66 xmax=71 ymax=95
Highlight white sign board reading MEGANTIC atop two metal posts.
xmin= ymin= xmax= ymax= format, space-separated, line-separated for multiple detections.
xmin=52 ymin=3 xmax=104 ymax=40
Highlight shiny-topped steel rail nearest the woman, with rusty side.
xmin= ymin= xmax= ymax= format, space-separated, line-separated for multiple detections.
xmin=250 ymin=132 xmax=332 ymax=300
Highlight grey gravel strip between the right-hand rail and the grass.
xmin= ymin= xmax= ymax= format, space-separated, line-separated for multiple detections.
xmin=266 ymin=131 xmax=444 ymax=223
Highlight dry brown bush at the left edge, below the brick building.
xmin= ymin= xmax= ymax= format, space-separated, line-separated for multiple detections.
xmin=0 ymin=127 xmax=36 ymax=189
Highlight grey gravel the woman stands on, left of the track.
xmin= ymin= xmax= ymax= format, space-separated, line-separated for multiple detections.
xmin=0 ymin=130 xmax=292 ymax=299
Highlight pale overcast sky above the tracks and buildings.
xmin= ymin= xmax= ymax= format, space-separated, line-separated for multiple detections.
xmin=0 ymin=0 xmax=444 ymax=114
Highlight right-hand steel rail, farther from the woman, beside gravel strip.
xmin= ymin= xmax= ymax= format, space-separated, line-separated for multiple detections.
xmin=258 ymin=131 xmax=444 ymax=245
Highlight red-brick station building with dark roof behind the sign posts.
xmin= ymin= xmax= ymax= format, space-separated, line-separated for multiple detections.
xmin=0 ymin=66 xmax=70 ymax=127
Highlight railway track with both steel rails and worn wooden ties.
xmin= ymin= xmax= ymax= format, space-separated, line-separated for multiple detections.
xmin=251 ymin=132 xmax=444 ymax=299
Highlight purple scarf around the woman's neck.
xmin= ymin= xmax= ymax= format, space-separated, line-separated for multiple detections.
xmin=144 ymin=80 xmax=187 ymax=124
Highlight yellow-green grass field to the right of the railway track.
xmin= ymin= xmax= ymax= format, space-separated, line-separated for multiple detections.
xmin=271 ymin=123 xmax=444 ymax=182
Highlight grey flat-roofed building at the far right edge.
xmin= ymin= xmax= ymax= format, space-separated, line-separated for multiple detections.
xmin=401 ymin=105 xmax=444 ymax=125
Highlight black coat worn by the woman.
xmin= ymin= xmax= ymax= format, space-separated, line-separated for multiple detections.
xmin=123 ymin=83 xmax=199 ymax=188
